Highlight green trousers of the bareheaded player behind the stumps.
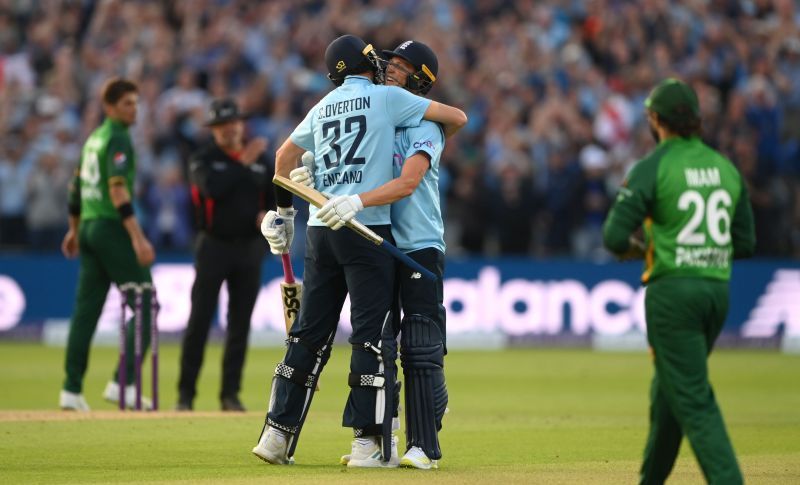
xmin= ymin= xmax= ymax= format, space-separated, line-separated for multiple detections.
xmin=63 ymin=219 xmax=152 ymax=393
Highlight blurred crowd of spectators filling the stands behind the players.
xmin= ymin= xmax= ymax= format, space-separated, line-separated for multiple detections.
xmin=0 ymin=0 xmax=800 ymax=260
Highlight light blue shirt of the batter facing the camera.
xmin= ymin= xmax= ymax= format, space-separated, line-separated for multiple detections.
xmin=391 ymin=120 xmax=445 ymax=253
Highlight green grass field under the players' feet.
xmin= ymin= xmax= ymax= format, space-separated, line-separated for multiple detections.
xmin=0 ymin=343 xmax=800 ymax=485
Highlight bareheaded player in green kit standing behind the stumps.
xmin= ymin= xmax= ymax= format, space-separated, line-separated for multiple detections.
xmin=59 ymin=79 xmax=155 ymax=411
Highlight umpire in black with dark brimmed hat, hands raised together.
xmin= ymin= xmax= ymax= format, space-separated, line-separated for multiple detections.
xmin=176 ymin=99 xmax=273 ymax=411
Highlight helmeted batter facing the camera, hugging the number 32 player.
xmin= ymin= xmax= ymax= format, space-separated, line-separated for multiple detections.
xmin=291 ymin=40 xmax=447 ymax=470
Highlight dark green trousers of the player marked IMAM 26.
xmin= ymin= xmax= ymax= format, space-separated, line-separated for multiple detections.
xmin=640 ymin=278 xmax=743 ymax=484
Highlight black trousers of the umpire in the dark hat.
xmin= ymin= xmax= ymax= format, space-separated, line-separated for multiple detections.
xmin=178 ymin=234 xmax=265 ymax=402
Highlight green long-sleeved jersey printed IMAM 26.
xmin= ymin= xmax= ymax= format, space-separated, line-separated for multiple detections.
xmin=603 ymin=137 xmax=755 ymax=283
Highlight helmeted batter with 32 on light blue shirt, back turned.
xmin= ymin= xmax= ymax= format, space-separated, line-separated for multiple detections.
xmin=253 ymin=35 xmax=466 ymax=467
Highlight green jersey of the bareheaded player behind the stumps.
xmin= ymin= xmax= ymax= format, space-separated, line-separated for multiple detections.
xmin=70 ymin=118 xmax=136 ymax=220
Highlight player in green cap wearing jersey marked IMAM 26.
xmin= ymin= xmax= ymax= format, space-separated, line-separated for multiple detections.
xmin=603 ymin=79 xmax=755 ymax=484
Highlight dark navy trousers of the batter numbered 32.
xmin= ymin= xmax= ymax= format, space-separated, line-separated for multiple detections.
xmin=268 ymin=225 xmax=395 ymax=429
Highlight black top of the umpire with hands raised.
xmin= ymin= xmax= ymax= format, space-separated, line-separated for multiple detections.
xmin=189 ymin=142 xmax=274 ymax=241
